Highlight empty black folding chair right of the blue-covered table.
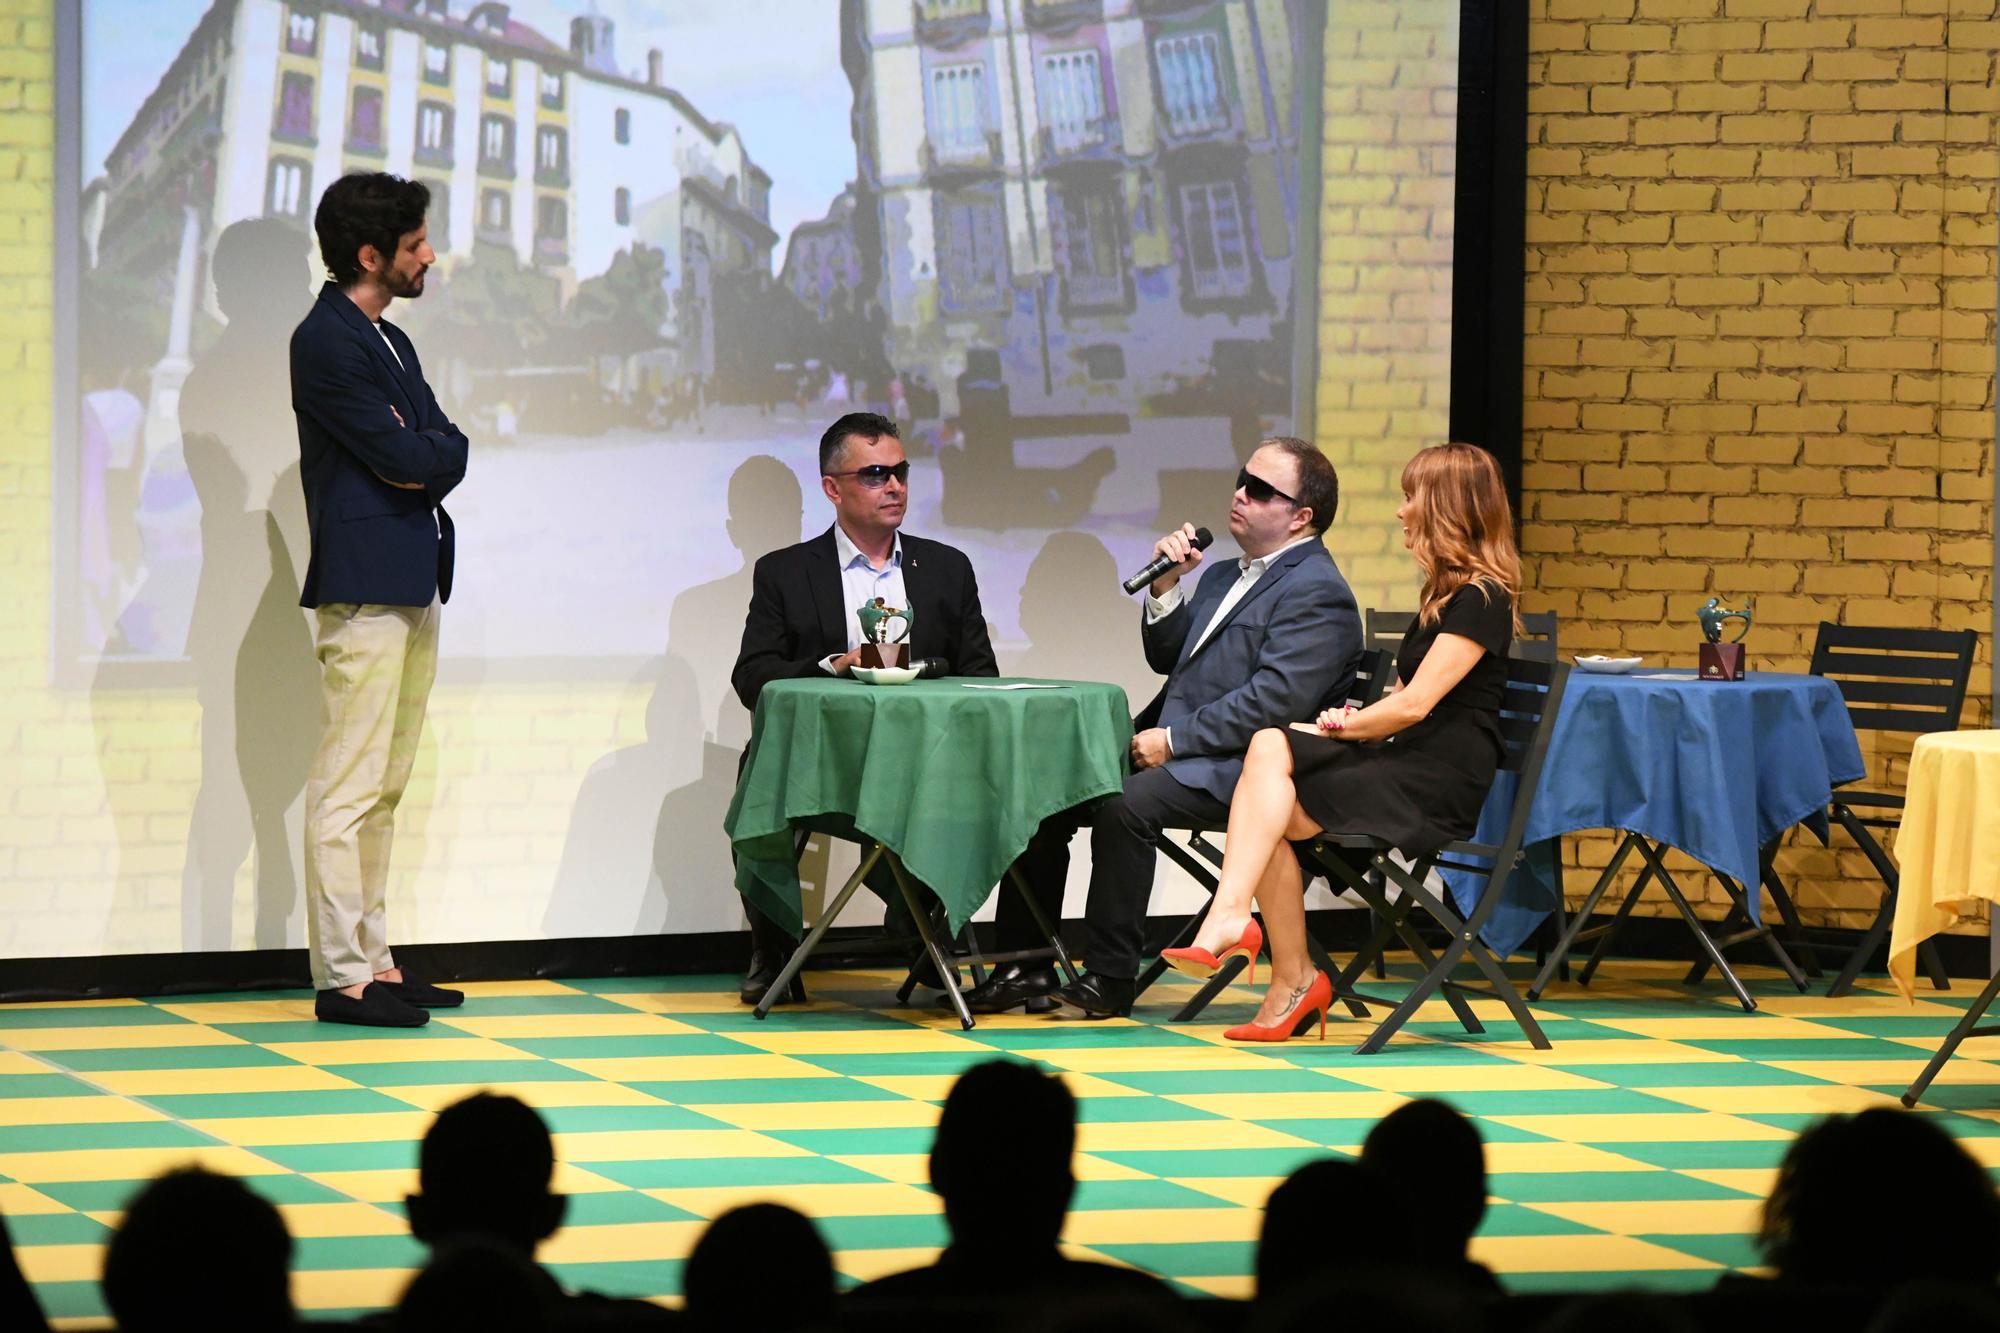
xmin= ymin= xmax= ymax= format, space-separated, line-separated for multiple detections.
xmin=1694 ymin=620 xmax=1978 ymax=995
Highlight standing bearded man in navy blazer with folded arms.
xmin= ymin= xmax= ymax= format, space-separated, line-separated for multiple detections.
xmin=292 ymin=172 xmax=466 ymax=1027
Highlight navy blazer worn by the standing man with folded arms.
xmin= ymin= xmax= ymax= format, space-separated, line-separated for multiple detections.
xmin=292 ymin=282 xmax=466 ymax=606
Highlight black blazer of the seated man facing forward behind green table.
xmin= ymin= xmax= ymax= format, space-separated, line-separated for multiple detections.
xmin=730 ymin=528 xmax=1000 ymax=713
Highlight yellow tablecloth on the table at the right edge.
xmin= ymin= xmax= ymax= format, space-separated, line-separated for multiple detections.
xmin=1888 ymin=731 xmax=2000 ymax=999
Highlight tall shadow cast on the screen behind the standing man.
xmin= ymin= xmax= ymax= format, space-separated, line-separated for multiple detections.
xmin=180 ymin=218 xmax=320 ymax=949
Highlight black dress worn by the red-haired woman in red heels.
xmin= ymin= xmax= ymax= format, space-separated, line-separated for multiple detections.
xmin=1286 ymin=582 xmax=1514 ymax=855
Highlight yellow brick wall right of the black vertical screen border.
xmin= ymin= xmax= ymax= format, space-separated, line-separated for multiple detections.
xmin=1522 ymin=0 xmax=2000 ymax=925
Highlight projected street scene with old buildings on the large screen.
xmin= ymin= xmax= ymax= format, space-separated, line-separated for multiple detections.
xmin=74 ymin=0 xmax=1322 ymax=669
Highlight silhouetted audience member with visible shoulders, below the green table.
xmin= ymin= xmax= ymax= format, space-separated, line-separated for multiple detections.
xmin=844 ymin=1061 xmax=1180 ymax=1329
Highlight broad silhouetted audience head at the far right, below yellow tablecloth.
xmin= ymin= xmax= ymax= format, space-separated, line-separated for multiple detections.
xmin=1758 ymin=1107 xmax=2000 ymax=1287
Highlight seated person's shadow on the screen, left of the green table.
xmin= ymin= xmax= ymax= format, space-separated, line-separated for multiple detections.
xmin=542 ymin=454 xmax=804 ymax=939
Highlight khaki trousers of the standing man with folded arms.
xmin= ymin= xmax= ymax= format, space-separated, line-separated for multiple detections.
xmin=306 ymin=600 xmax=438 ymax=991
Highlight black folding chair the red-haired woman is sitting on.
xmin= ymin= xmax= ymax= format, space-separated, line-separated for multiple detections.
xmin=1306 ymin=656 xmax=1570 ymax=1055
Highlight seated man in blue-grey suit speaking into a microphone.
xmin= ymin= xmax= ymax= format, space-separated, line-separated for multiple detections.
xmin=992 ymin=436 xmax=1362 ymax=1017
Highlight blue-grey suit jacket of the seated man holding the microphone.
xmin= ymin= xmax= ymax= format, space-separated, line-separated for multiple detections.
xmin=1138 ymin=540 xmax=1362 ymax=801
